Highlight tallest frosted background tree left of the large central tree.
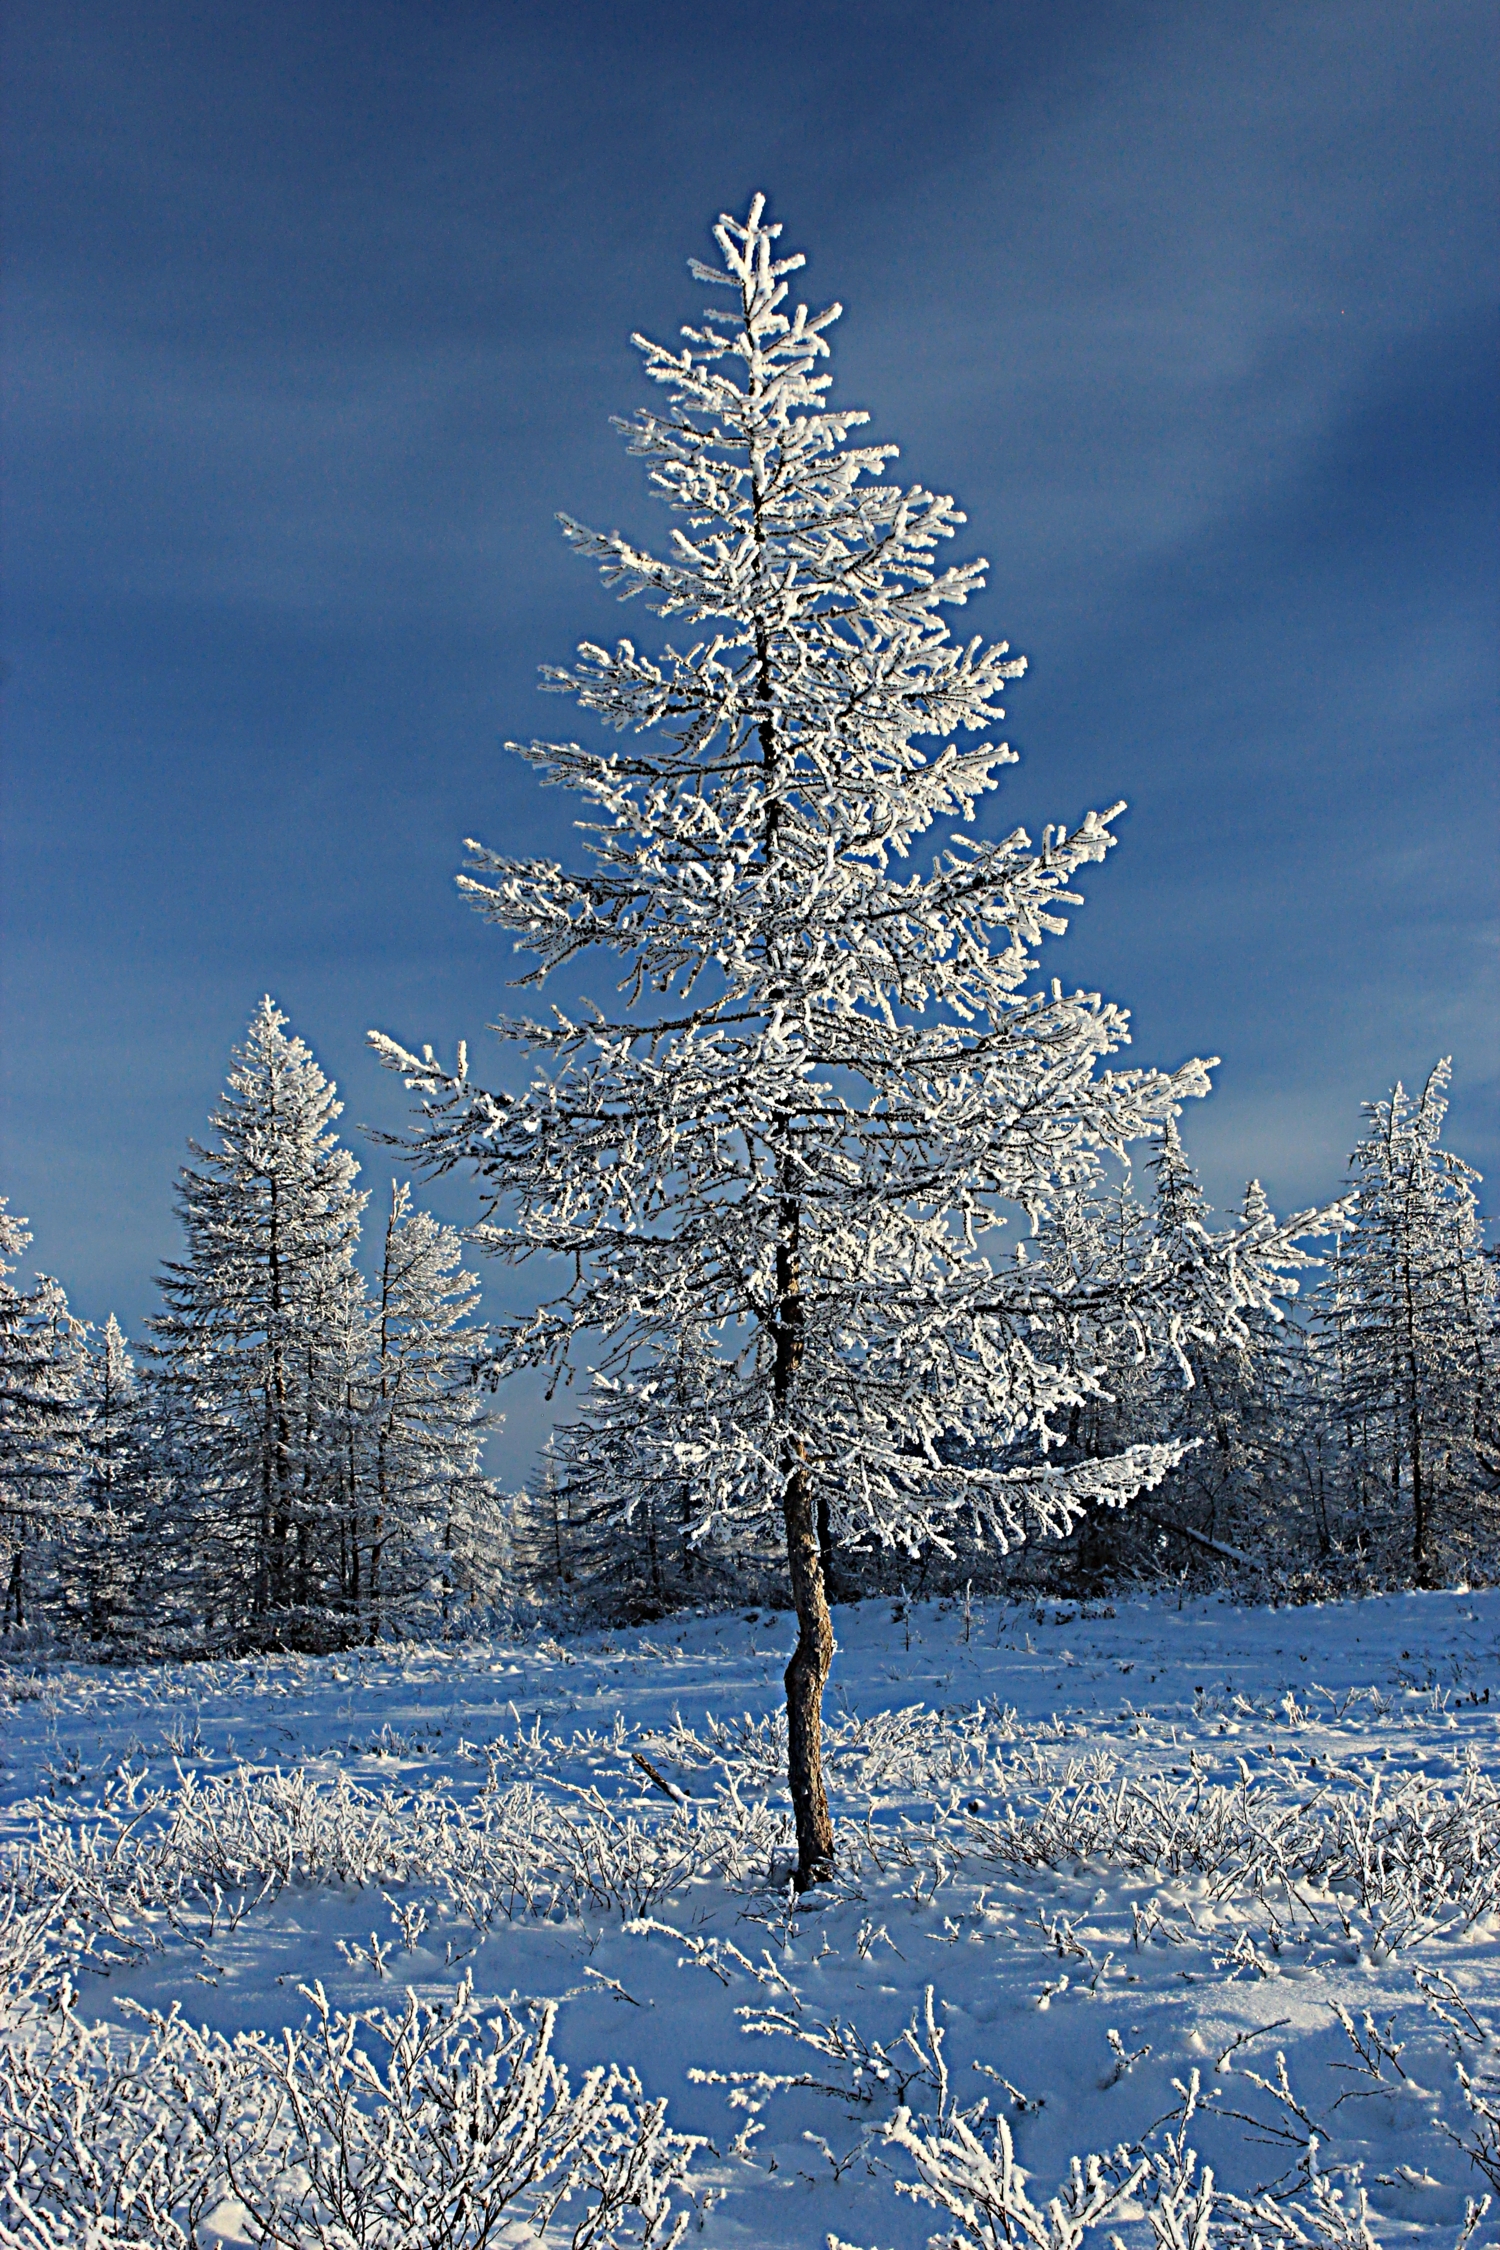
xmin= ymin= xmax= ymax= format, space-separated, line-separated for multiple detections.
xmin=151 ymin=999 xmax=364 ymax=1622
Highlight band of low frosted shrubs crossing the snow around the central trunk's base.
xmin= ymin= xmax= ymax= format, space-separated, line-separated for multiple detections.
xmin=14 ymin=1708 xmax=1500 ymax=1967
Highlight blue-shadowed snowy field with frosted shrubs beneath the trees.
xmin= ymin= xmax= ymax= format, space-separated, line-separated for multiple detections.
xmin=0 ymin=1593 xmax=1500 ymax=2250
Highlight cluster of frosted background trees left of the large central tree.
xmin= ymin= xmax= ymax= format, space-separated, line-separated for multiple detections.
xmin=0 ymin=999 xmax=508 ymax=1654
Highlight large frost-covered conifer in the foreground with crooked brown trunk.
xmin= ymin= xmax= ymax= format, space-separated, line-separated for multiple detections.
xmin=376 ymin=198 xmax=1322 ymax=1886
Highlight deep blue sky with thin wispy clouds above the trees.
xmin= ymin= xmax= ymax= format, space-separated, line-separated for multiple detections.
xmin=0 ymin=0 xmax=1500 ymax=1476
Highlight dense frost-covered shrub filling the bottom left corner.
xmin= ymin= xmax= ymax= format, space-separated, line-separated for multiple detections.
xmin=0 ymin=1982 xmax=695 ymax=2250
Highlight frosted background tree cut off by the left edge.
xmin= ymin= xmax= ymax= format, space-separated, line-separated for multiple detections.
xmin=0 ymin=1197 xmax=83 ymax=1629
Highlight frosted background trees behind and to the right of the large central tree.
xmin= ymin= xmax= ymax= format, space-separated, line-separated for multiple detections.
xmin=513 ymin=1062 xmax=1500 ymax=1620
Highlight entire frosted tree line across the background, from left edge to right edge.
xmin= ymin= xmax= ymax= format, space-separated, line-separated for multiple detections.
xmin=0 ymin=1030 xmax=1500 ymax=1656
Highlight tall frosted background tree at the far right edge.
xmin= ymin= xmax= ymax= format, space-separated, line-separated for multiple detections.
xmin=1318 ymin=1060 xmax=1500 ymax=1584
